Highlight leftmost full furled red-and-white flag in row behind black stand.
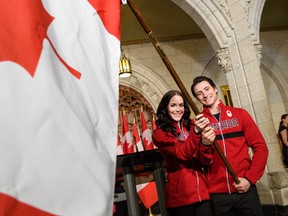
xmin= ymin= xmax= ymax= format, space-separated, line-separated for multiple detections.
xmin=122 ymin=111 xmax=135 ymax=154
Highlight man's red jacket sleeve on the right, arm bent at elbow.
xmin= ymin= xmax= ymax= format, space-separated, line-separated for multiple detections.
xmin=241 ymin=110 xmax=268 ymax=184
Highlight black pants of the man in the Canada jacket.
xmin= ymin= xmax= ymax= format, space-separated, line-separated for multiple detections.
xmin=210 ymin=185 xmax=263 ymax=216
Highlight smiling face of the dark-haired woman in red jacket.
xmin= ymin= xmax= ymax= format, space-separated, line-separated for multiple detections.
xmin=167 ymin=95 xmax=184 ymax=122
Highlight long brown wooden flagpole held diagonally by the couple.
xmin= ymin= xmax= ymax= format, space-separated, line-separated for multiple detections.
xmin=127 ymin=0 xmax=240 ymax=184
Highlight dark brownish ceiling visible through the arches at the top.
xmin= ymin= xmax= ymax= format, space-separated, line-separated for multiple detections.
xmin=121 ymin=0 xmax=288 ymax=44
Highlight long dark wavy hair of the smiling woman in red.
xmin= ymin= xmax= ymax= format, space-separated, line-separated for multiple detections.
xmin=156 ymin=90 xmax=191 ymax=137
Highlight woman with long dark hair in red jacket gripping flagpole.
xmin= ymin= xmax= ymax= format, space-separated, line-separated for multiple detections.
xmin=153 ymin=90 xmax=215 ymax=216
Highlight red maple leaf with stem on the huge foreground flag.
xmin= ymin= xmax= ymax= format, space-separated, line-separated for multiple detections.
xmin=0 ymin=0 xmax=81 ymax=79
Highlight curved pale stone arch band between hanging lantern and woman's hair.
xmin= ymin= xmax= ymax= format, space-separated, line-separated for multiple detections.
xmin=119 ymin=60 xmax=169 ymax=112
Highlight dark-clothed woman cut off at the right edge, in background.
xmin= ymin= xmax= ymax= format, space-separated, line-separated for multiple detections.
xmin=278 ymin=114 xmax=288 ymax=168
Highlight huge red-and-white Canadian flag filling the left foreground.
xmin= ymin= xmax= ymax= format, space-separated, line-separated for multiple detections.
xmin=0 ymin=0 xmax=120 ymax=216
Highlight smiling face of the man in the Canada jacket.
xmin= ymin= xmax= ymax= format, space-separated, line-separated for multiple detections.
xmin=194 ymin=81 xmax=218 ymax=107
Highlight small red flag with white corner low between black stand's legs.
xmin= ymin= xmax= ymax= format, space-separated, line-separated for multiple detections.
xmin=136 ymin=181 xmax=158 ymax=209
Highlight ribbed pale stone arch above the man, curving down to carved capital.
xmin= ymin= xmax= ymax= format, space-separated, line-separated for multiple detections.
xmin=171 ymin=0 xmax=233 ymax=50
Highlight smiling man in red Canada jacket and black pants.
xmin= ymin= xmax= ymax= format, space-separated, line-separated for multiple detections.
xmin=191 ymin=76 xmax=268 ymax=216
